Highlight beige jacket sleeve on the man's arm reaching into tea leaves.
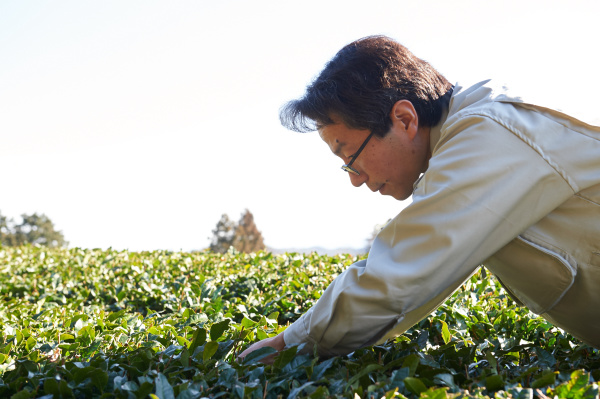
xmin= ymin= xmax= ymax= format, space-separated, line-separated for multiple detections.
xmin=284 ymin=105 xmax=574 ymax=356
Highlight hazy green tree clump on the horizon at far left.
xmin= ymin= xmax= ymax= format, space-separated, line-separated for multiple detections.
xmin=0 ymin=213 xmax=68 ymax=247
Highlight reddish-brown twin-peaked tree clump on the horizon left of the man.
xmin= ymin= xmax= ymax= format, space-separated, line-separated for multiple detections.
xmin=209 ymin=209 xmax=266 ymax=253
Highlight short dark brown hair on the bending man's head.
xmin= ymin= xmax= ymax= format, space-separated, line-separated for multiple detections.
xmin=279 ymin=36 xmax=452 ymax=136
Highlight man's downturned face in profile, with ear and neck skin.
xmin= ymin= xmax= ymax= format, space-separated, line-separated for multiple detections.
xmin=319 ymin=106 xmax=429 ymax=200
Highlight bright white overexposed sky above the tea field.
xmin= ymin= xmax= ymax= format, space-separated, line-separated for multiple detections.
xmin=0 ymin=0 xmax=600 ymax=251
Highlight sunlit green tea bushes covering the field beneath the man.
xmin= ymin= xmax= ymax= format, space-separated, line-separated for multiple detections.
xmin=0 ymin=246 xmax=600 ymax=399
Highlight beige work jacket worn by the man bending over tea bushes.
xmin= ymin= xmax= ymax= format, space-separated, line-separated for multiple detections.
xmin=284 ymin=81 xmax=600 ymax=355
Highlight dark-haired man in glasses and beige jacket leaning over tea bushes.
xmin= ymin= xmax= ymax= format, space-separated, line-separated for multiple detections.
xmin=241 ymin=36 xmax=600 ymax=357
